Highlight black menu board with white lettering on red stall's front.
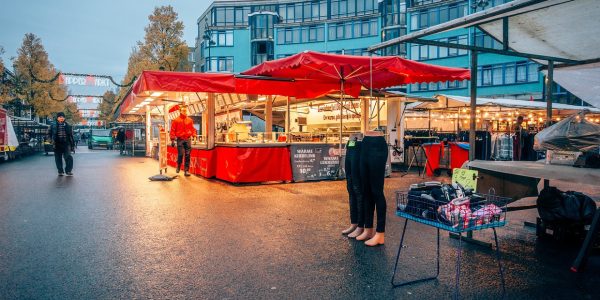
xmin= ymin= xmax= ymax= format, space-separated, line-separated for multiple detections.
xmin=290 ymin=144 xmax=345 ymax=181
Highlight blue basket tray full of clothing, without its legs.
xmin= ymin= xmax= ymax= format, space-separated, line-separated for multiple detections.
xmin=395 ymin=191 xmax=510 ymax=233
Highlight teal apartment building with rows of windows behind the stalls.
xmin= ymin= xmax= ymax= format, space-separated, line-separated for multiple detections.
xmin=194 ymin=0 xmax=581 ymax=105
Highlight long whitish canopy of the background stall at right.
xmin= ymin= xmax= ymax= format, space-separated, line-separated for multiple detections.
xmin=407 ymin=94 xmax=600 ymax=113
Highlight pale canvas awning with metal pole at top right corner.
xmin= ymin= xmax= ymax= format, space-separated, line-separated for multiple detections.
xmin=369 ymin=0 xmax=600 ymax=107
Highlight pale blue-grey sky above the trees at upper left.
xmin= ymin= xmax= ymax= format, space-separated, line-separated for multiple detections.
xmin=0 ymin=0 xmax=212 ymax=80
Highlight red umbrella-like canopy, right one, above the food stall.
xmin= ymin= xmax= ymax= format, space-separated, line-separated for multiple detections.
xmin=242 ymin=51 xmax=470 ymax=97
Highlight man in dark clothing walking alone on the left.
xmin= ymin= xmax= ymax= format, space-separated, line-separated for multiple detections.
xmin=48 ymin=112 xmax=75 ymax=176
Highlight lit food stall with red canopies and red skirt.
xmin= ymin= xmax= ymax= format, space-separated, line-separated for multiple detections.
xmin=116 ymin=53 xmax=469 ymax=182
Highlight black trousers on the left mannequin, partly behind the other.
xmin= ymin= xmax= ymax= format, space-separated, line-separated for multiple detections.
xmin=344 ymin=141 xmax=365 ymax=227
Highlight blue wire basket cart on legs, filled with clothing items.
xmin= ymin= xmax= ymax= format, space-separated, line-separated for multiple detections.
xmin=391 ymin=187 xmax=510 ymax=299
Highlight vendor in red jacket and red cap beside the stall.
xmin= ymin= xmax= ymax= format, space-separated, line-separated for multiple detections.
xmin=170 ymin=105 xmax=196 ymax=176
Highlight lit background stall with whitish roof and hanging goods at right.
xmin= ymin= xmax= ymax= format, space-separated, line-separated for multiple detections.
xmin=403 ymin=94 xmax=600 ymax=170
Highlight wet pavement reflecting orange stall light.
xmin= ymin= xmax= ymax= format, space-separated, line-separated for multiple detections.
xmin=0 ymin=147 xmax=600 ymax=299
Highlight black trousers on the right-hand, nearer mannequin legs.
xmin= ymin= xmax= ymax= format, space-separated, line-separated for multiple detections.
xmin=359 ymin=136 xmax=388 ymax=232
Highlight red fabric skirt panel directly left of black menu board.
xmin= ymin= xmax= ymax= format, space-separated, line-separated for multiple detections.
xmin=215 ymin=146 xmax=292 ymax=183
